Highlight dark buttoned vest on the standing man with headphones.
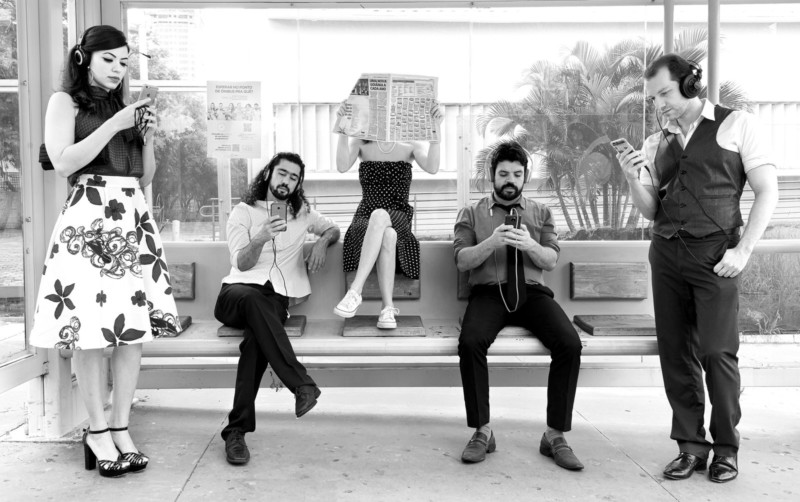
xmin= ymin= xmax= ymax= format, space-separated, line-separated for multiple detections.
xmin=653 ymin=106 xmax=747 ymax=238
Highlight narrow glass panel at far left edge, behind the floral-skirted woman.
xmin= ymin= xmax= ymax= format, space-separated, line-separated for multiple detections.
xmin=0 ymin=1 xmax=26 ymax=364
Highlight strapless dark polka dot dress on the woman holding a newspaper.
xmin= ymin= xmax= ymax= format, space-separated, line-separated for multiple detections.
xmin=343 ymin=161 xmax=419 ymax=279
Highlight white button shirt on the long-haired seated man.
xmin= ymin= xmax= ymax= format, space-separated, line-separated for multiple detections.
xmin=222 ymin=200 xmax=336 ymax=298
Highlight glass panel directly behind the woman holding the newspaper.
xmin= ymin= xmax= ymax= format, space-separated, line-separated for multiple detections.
xmin=296 ymin=9 xmax=470 ymax=240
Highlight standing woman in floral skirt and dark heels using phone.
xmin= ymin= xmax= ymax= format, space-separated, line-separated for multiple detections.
xmin=31 ymin=26 xmax=180 ymax=476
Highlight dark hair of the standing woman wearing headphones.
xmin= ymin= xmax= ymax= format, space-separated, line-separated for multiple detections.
xmin=61 ymin=25 xmax=130 ymax=113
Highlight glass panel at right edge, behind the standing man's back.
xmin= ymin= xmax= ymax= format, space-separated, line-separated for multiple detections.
xmin=720 ymin=2 xmax=800 ymax=335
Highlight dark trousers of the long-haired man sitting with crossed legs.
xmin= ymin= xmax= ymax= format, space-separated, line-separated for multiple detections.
xmin=214 ymin=282 xmax=314 ymax=439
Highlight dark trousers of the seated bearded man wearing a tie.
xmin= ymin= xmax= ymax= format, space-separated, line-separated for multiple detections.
xmin=458 ymin=284 xmax=581 ymax=432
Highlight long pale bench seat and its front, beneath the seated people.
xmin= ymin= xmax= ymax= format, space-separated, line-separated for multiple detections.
xmin=139 ymin=319 xmax=661 ymax=388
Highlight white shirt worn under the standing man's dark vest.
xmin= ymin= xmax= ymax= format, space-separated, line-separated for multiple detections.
xmin=639 ymin=99 xmax=775 ymax=187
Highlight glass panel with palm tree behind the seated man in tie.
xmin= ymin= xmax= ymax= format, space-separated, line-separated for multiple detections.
xmin=470 ymin=3 xmax=663 ymax=240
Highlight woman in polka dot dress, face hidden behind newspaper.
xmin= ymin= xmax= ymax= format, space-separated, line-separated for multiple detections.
xmin=333 ymin=104 xmax=444 ymax=329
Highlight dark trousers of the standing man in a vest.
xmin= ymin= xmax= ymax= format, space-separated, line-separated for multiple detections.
xmin=650 ymin=232 xmax=742 ymax=456
